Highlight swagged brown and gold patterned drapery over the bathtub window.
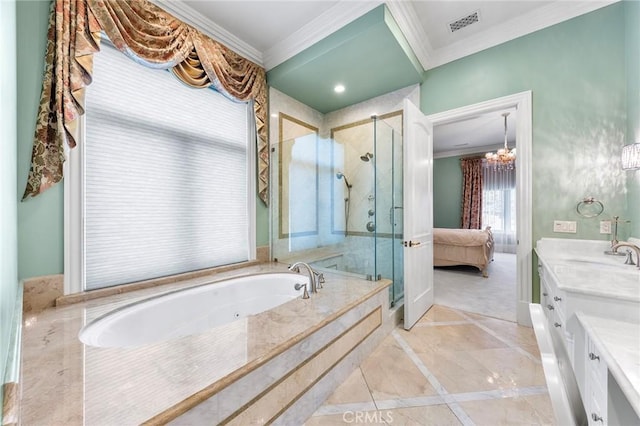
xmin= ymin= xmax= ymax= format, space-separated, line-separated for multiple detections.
xmin=23 ymin=0 xmax=269 ymax=204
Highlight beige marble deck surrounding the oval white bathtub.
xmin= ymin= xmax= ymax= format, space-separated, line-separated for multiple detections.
xmin=20 ymin=264 xmax=390 ymax=426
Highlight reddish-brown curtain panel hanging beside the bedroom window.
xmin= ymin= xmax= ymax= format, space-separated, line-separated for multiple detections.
xmin=460 ymin=158 xmax=482 ymax=229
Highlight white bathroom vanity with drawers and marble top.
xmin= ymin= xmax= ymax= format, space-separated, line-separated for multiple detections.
xmin=536 ymin=238 xmax=640 ymax=425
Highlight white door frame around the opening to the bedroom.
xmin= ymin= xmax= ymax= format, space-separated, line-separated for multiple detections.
xmin=427 ymin=90 xmax=533 ymax=326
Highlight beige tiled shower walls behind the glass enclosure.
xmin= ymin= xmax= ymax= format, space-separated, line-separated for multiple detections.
xmin=269 ymin=85 xmax=420 ymax=284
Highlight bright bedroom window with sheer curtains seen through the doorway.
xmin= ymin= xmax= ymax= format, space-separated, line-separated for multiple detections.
xmin=482 ymin=165 xmax=517 ymax=253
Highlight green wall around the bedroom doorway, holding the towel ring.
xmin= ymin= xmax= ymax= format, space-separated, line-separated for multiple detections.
xmin=421 ymin=3 xmax=627 ymax=246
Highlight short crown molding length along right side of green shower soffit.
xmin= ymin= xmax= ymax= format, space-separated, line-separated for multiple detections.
xmin=386 ymin=0 xmax=433 ymax=70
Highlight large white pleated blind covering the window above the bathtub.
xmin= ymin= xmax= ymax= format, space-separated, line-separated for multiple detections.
xmin=83 ymin=44 xmax=251 ymax=290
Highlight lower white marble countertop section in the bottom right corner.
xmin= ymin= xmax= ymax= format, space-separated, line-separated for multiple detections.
xmin=576 ymin=312 xmax=640 ymax=416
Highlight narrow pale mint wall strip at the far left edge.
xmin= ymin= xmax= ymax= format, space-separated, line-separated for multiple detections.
xmin=0 ymin=0 xmax=18 ymax=412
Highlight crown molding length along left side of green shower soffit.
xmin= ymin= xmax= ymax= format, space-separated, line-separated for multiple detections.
xmin=263 ymin=0 xmax=384 ymax=70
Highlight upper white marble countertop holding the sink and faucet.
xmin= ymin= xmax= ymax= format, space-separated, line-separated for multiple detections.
xmin=536 ymin=238 xmax=640 ymax=303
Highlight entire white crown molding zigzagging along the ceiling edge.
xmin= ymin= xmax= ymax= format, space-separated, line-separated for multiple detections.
xmin=145 ymin=0 xmax=619 ymax=70
